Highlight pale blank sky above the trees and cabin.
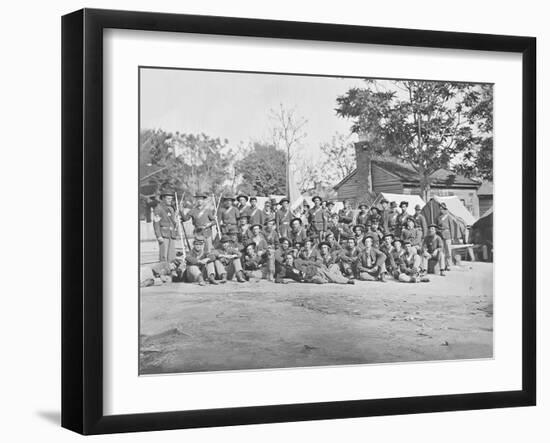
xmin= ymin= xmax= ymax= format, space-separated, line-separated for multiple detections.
xmin=140 ymin=68 xmax=363 ymax=159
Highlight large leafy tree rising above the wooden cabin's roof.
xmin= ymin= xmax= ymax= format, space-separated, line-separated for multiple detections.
xmin=336 ymin=80 xmax=494 ymax=197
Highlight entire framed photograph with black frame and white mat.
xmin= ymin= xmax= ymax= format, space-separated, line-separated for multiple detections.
xmin=62 ymin=9 xmax=537 ymax=434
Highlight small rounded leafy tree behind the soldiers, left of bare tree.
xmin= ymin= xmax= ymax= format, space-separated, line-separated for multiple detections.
xmin=235 ymin=142 xmax=286 ymax=196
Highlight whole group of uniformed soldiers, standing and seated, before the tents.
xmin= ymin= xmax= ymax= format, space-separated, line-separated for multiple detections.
xmin=141 ymin=190 xmax=458 ymax=286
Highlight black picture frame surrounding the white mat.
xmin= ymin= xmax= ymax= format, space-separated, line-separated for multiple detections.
xmin=62 ymin=9 xmax=537 ymax=434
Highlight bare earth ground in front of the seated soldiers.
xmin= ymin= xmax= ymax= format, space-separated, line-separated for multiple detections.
xmin=140 ymin=263 xmax=493 ymax=374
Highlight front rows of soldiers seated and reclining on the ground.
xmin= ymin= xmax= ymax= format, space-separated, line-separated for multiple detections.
xmin=141 ymin=223 xmax=445 ymax=286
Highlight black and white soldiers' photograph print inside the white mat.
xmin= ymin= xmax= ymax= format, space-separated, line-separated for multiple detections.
xmin=137 ymin=67 xmax=494 ymax=375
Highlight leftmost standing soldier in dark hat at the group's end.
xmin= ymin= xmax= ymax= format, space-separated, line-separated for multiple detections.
xmin=153 ymin=188 xmax=178 ymax=262
